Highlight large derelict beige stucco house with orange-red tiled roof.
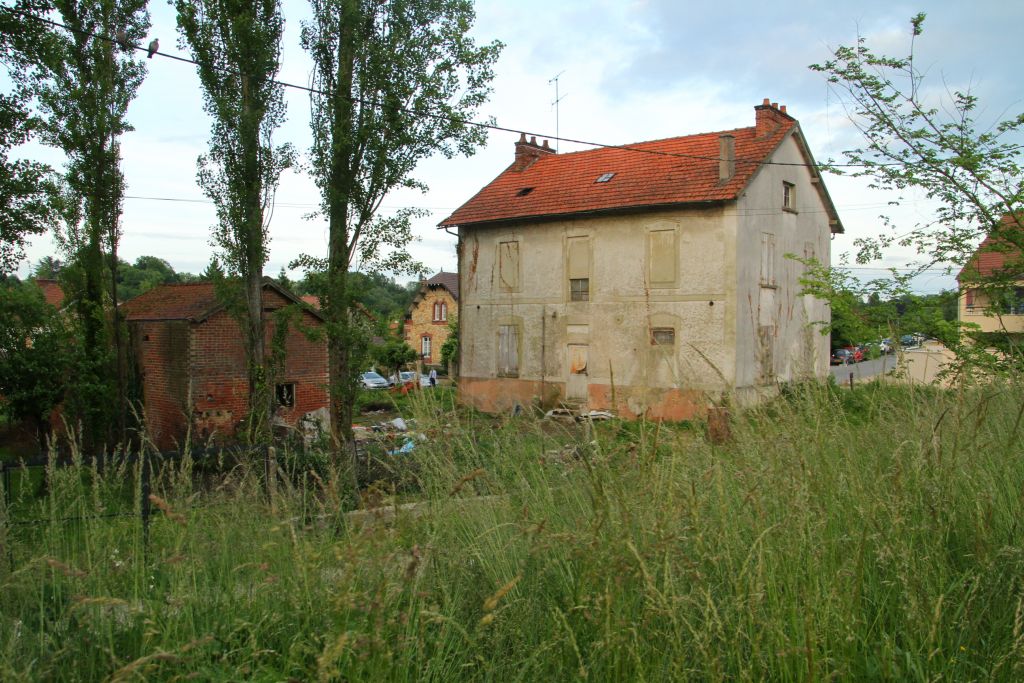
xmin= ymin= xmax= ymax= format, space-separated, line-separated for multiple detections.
xmin=440 ymin=100 xmax=843 ymax=420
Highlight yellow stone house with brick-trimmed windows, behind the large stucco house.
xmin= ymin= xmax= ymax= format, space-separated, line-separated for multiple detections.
xmin=403 ymin=270 xmax=459 ymax=366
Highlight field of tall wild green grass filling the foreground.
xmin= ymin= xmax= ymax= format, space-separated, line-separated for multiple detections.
xmin=0 ymin=382 xmax=1024 ymax=681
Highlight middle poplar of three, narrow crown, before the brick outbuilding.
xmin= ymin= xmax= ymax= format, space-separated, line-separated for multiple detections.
xmin=175 ymin=0 xmax=294 ymax=442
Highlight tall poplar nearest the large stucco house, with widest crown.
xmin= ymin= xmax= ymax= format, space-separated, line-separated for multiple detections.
xmin=302 ymin=0 xmax=502 ymax=441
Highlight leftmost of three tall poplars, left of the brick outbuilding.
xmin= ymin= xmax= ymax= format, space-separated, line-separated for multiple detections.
xmin=37 ymin=0 xmax=150 ymax=443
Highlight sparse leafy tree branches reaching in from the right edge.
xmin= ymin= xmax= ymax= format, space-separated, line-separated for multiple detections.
xmin=811 ymin=12 xmax=1024 ymax=369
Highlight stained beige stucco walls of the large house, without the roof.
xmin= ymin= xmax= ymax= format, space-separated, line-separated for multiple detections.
xmin=442 ymin=99 xmax=841 ymax=420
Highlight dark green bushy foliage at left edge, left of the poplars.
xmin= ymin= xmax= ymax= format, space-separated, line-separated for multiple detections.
xmin=0 ymin=279 xmax=74 ymax=436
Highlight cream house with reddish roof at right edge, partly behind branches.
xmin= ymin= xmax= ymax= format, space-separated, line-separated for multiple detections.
xmin=956 ymin=216 xmax=1024 ymax=334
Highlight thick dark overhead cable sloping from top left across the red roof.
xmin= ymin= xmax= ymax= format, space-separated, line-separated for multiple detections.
xmin=3 ymin=7 xmax=904 ymax=170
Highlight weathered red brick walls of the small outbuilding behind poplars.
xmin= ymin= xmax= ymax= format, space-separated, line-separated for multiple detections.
xmin=134 ymin=291 xmax=328 ymax=450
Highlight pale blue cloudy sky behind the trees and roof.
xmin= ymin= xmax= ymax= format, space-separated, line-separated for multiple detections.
xmin=9 ymin=0 xmax=1024 ymax=292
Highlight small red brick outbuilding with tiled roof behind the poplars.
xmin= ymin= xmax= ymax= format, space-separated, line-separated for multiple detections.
xmin=122 ymin=279 xmax=328 ymax=450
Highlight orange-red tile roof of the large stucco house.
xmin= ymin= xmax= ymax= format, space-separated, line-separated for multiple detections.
xmin=440 ymin=105 xmax=798 ymax=226
